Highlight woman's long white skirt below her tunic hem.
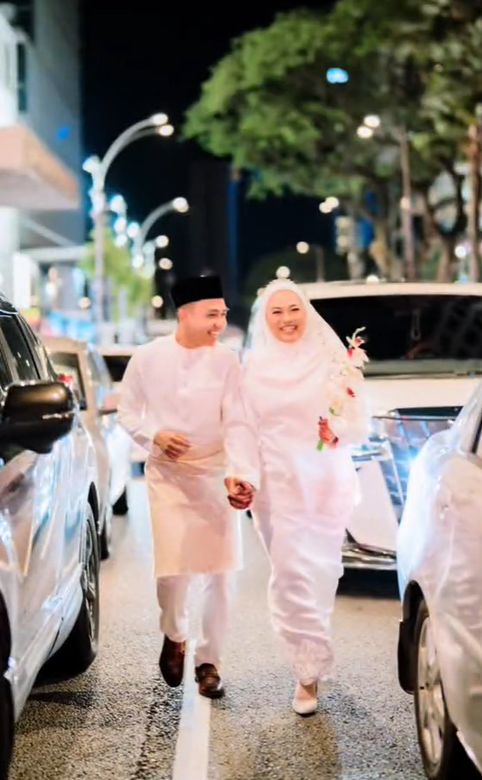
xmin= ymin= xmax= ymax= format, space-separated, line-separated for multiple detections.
xmin=254 ymin=507 xmax=347 ymax=685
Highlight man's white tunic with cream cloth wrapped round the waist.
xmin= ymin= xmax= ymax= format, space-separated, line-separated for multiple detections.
xmin=119 ymin=335 xmax=259 ymax=577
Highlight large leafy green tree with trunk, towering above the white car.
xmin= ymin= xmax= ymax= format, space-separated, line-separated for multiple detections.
xmin=184 ymin=0 xmax=466 ymax=280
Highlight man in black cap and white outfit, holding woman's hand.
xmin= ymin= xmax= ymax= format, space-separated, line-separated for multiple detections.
xmin=119 ymin=276 xmax=258 ymax=698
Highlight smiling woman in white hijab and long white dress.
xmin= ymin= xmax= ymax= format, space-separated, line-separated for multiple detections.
xmin=241 ymin=281 xmax=368 ymax=715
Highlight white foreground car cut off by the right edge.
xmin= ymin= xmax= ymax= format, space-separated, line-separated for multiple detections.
xmin=397 ymin=386 xmax=482 ymax=780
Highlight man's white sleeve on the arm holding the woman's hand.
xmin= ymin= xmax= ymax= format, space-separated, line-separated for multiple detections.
xmin=222 ymin=353 xmax=260 ymax=490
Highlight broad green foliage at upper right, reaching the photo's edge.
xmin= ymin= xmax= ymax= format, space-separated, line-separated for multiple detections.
xmin=184 ymin=0 xmax=482 ymax=280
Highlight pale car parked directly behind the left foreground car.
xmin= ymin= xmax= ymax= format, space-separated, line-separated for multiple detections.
xmin=44 ymin=336 xmax=131 ymax=558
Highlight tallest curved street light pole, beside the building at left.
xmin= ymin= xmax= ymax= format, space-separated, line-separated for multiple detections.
xmin=83 ymin=114 xmax=174 ymax=341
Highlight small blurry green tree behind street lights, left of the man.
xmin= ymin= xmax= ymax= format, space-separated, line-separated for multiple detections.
xmin=80 ymin=228 xmax=152 ymax=320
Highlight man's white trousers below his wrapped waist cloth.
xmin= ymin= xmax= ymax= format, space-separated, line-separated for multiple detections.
xmin=157 ymin=572 xmax=233 ymax=669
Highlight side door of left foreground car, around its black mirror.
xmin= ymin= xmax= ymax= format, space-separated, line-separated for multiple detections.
xmin=0 ymin=313 xmax=67 ymax=674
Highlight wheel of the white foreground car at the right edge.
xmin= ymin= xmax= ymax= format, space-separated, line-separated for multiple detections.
xmin=414 ymin=599 xmax=480 ymax=780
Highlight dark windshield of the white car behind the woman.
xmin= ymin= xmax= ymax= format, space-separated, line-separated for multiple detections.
xmin=311 ymin=294 xmax=482 ymax=376
